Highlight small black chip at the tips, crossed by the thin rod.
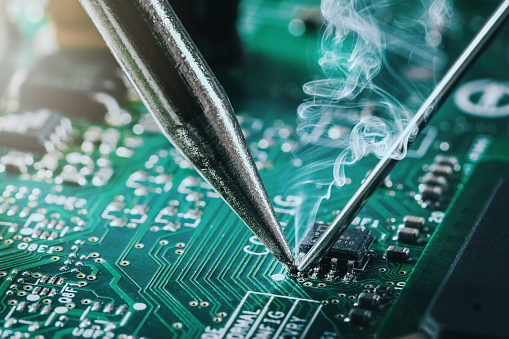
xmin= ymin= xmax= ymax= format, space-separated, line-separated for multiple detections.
xmin=299 ymin=223 xmax=373 ymax=269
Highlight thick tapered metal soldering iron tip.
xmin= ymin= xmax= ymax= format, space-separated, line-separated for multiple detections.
xmin=80 ymin=0 xmax=295 ymax=269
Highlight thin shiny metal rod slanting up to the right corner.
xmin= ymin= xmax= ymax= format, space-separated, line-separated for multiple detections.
xmin=297 ymin=0 xmax=509 ymax=271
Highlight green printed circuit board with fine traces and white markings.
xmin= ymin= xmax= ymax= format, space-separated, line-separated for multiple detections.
xmin=0 ymin=0 xmax=509 ymax=339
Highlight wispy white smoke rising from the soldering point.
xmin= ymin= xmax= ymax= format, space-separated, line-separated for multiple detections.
xmin=287 ymin=0 xmax=452 ymax=247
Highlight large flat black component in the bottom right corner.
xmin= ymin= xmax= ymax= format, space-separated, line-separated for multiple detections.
xmin=421 ymin=179 xmax=509 ymax=338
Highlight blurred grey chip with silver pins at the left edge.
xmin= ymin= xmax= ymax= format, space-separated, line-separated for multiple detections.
xmin=0 ymin=109 xmax=71 ymax=153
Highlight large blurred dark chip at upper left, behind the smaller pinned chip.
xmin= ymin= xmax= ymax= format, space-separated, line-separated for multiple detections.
xmin=20 ymin=50 xmax=127 ymax=121
